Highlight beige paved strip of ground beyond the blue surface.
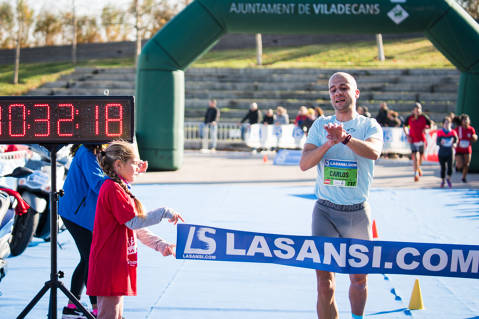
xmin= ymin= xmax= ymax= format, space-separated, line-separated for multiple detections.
xmin=136 ymin=151 xmax=479 ymax=189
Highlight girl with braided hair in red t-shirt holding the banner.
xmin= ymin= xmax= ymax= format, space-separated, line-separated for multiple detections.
xmin=87 ymin=141 xmax=183 ymax=319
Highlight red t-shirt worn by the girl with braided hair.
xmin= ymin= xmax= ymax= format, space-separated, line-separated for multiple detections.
xmin=87 ymin=179 xmax=137 ymax=296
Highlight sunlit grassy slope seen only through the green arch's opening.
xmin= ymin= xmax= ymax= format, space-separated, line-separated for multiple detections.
xmin=193 ymin=38 xmax=454 ymax=69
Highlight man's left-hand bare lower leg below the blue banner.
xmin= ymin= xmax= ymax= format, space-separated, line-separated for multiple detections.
xmin=316 ymin=270 xmax=338 ymax=319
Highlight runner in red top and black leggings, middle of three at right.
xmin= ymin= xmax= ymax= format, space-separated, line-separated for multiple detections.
xmin=436 ymin=116 xmax=457 ymax=188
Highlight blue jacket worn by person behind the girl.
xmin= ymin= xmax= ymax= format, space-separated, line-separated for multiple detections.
xmin=58 ymin=145 xmax=108 ymax=231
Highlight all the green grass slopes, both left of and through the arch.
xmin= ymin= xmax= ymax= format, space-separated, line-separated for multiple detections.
xmin=0 ymin=38 xmax=454 ymax=95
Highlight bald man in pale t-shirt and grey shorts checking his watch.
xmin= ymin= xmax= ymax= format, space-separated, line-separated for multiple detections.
xmin=299 ymin=72 xmax=383 ymax=319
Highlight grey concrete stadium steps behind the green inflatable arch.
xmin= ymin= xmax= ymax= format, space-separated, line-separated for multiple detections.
xmin=29 ymin=68 xmax=460 ymax=122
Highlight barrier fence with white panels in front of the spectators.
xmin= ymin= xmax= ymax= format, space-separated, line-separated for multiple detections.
xmin=184 ymin=122 xmax=438 ymax=162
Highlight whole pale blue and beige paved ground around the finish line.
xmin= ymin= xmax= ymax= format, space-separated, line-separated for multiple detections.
xmin=0 ymin=151 xmax=479 ymax=319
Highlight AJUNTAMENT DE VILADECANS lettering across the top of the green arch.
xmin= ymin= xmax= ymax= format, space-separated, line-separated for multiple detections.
xmin=229 ymin=2 xmax=381 ymax=15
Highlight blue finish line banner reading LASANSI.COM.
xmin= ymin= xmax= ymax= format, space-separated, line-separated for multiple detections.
xmin=176 ymin=224 xmax=479 ymax=279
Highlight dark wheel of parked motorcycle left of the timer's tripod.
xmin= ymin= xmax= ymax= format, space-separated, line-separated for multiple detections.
xmin=10 ymin=209 xmax=39 ymax=256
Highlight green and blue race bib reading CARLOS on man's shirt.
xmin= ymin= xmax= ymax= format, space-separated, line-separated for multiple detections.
xmin=323 ymin=159 xmax=358 ymax=187
